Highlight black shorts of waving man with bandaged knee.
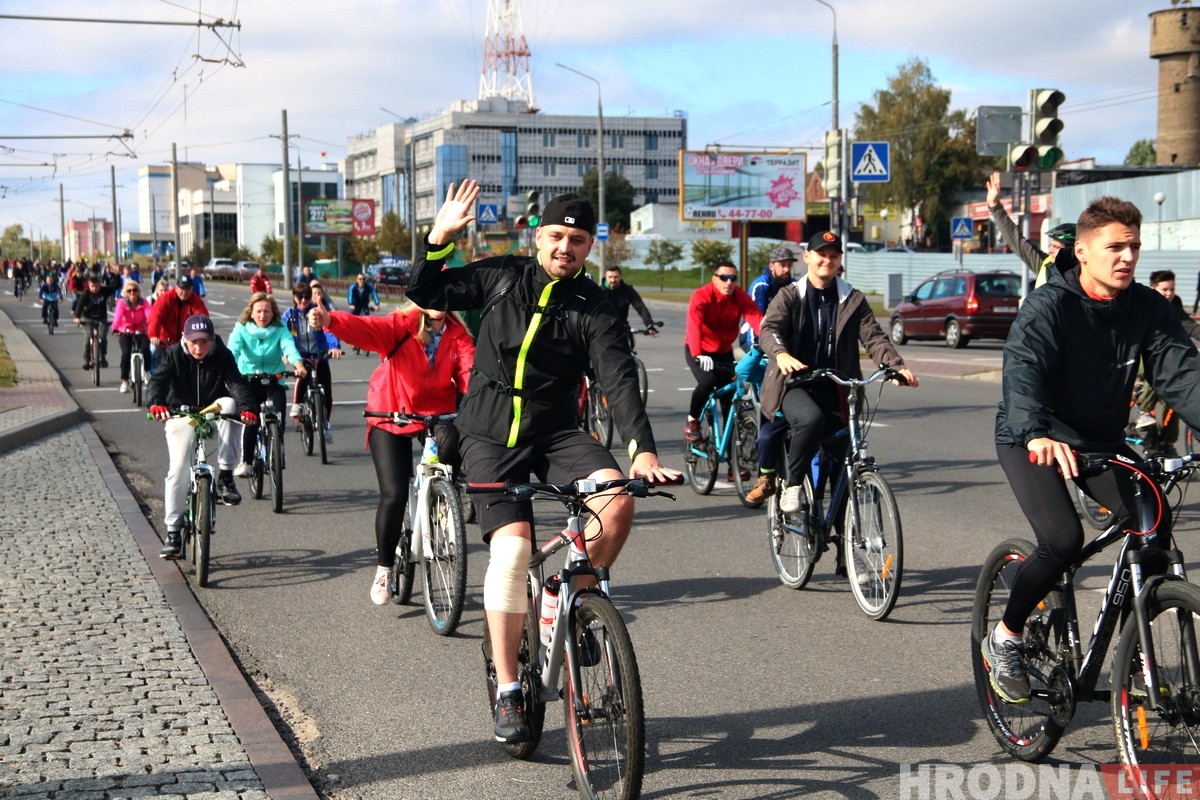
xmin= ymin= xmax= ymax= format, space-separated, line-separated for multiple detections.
xmin=458 ymin=431 xmax=620 ymax=542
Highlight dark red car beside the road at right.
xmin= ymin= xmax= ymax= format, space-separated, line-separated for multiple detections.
xmin=889 ymin=270 xmax=1021 ymax=348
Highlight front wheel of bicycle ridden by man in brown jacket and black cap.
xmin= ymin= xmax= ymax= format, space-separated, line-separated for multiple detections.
xmin=844 ymin=473 xmax=904 ymax=619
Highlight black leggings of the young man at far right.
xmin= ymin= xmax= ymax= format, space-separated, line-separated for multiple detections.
xmin=996 ymin=445 xmax=1152 ymax=633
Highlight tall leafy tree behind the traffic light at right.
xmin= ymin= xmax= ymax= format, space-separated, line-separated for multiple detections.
xmin=853 ymin=58 xmax=991 ymax=248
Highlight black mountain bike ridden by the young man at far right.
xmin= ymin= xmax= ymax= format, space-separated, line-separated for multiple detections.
xmin=971 ymin=453 xmax=1200 ymax=782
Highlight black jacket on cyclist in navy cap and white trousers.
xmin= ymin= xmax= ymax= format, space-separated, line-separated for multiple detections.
xmin=146 ymin=336 xmax=258 ymax=413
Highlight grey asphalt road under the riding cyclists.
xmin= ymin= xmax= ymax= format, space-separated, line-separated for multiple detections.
xmin=16 ymin=284 xmax=1195 ymax=800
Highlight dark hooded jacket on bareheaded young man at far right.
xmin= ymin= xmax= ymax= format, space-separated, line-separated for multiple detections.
xmin=996 ymin=248 xmax=1200 ymax=452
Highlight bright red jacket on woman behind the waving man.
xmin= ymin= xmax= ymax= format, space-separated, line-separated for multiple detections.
xmin=326 ymin=309 xmax=475 ymax=434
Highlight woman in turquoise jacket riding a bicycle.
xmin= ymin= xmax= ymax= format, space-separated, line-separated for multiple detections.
xmin=229 ymin=291 xmax=307 ymax=477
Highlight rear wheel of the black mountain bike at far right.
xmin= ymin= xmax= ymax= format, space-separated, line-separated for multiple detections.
xmin=971 ymin=539 xmax=1075 ymax=762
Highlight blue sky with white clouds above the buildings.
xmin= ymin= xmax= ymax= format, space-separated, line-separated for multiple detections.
xmin=0 ymin=0 xmax=1169 ymax=236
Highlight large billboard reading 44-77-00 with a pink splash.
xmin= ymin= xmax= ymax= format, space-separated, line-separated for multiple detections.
xmin=679 ymin=150 xmax=808 ymax=222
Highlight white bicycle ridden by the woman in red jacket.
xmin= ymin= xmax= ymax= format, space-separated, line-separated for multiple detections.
xmin=362 ymin=411 xmax=467 ymax=636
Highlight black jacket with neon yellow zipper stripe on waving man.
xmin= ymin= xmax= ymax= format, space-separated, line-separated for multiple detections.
xmin=408 ymin=242 xmax=655 ymax=458
